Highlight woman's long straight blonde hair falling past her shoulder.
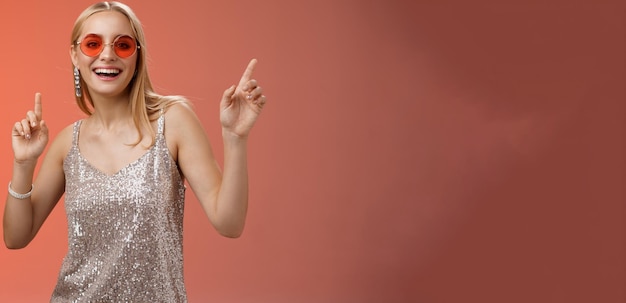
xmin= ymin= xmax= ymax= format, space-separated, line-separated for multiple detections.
xmin=71 ymin=1 xmax=188 ymax=145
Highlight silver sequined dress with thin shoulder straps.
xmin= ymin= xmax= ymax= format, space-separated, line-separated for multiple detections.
xmin=50 ymin=115 xmax=187 ymax=303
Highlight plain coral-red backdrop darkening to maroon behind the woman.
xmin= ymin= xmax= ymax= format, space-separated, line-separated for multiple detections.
xmin=0 ymin=0 xmax=626 ymax=303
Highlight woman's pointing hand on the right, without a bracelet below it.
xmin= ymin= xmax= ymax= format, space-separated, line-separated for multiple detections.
xmin=220 ymin=59 xmax=267 ymax=137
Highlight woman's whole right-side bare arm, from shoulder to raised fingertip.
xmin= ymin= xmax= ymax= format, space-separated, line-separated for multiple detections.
xmin=166 ymin=59 xmax=266 ymax=238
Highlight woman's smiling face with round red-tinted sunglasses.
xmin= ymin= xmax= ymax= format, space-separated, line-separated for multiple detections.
xmin=70 ymin=11 xmax=139 ymax=98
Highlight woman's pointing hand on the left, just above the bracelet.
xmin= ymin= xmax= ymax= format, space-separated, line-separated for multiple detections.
xmin=12 ymin=93 xmax=48 ymax=163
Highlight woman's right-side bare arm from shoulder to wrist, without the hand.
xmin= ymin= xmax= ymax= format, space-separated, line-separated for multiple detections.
xmin=165 ymin=104 xmax=248 ymax=237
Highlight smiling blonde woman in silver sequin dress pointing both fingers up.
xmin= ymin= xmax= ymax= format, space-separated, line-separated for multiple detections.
xmin=4 ymin=2 xmax=266 ymax=302
